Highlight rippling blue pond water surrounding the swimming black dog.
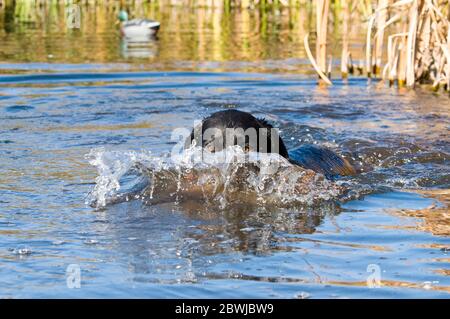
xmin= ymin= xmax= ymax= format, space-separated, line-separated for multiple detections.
xmin=0 ymin=3 xmax=450 ymax=298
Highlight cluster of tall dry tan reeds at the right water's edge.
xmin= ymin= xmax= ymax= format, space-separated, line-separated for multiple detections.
xmin=305 ymin=0 xmax=450 ymax=90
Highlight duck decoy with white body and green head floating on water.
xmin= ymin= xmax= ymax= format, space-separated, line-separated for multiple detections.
xmin=119 ymin=11 xmax=160 ymax=38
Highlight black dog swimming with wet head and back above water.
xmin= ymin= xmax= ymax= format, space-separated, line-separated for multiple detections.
xmin=186 ymin=110 xmax=355 ymax=179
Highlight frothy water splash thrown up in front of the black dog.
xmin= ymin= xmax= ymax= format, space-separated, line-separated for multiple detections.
xmin=87 ymin=146 xmax=344 ymax=208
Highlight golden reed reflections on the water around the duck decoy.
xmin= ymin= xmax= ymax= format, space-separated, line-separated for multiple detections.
xmin=0 ymin=2 xmax=364 ymax=74
